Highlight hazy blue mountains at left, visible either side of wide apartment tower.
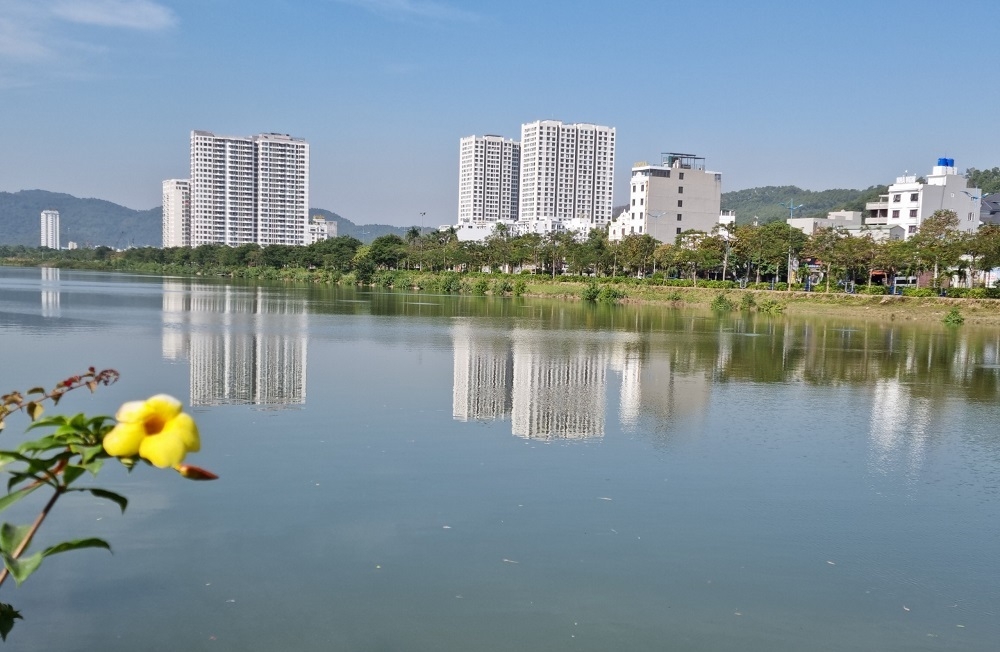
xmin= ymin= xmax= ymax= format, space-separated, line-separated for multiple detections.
xmin=0 ymin=190 xmax=409 ymax=249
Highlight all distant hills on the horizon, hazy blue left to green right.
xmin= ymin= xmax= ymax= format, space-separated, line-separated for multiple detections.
xmin=0 ymin=186 xmax=885 ymax=249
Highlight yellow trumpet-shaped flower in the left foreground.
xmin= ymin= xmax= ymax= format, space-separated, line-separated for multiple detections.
xmin=104 ymin=394 xmax=201 ymax=469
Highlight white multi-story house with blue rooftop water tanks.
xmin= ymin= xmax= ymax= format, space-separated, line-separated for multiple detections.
xmin=865 ymin=158 xmax=983 ymax=239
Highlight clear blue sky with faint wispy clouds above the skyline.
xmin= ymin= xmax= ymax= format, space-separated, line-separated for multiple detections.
xmin=0 ymin=0 xmax=1000 ymax=226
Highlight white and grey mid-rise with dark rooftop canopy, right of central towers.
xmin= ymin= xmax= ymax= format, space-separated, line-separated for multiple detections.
xmin=608 ymin=152 xmax=722 ymax=243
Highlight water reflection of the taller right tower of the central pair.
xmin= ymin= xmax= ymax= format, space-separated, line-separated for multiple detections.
xmin=511 ymin=329 xmax=609 ymax=439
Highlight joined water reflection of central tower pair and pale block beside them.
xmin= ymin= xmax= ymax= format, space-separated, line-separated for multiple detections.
xmin=452 ymin=322 xmax=709 ymax=440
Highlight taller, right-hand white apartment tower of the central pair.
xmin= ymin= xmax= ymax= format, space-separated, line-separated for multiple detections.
xmin=518 ymin=120 xmax=615 ymax=232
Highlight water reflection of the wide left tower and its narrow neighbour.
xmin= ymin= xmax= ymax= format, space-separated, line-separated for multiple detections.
xmin=162 ymin=281 xmax=308 ymax=407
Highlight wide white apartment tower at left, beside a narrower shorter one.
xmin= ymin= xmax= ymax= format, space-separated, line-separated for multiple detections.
xmin=190 ymin=131 xmax=309 ymax=246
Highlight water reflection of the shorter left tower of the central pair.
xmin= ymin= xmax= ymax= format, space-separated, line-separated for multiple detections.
xmin=452 ymin=323 xmax=514 ymax=421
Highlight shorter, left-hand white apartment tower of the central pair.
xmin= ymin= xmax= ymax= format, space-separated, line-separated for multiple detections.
xmin=458 ymin=136 xmax=521 ymax=227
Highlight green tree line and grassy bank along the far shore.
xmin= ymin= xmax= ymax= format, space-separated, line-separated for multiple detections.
xmin=0 ymin=211 xmax=1000 ymax=323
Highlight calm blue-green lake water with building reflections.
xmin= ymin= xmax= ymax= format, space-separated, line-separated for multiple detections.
xmin=0 ymin=268 xmax=1000 ymax=652
